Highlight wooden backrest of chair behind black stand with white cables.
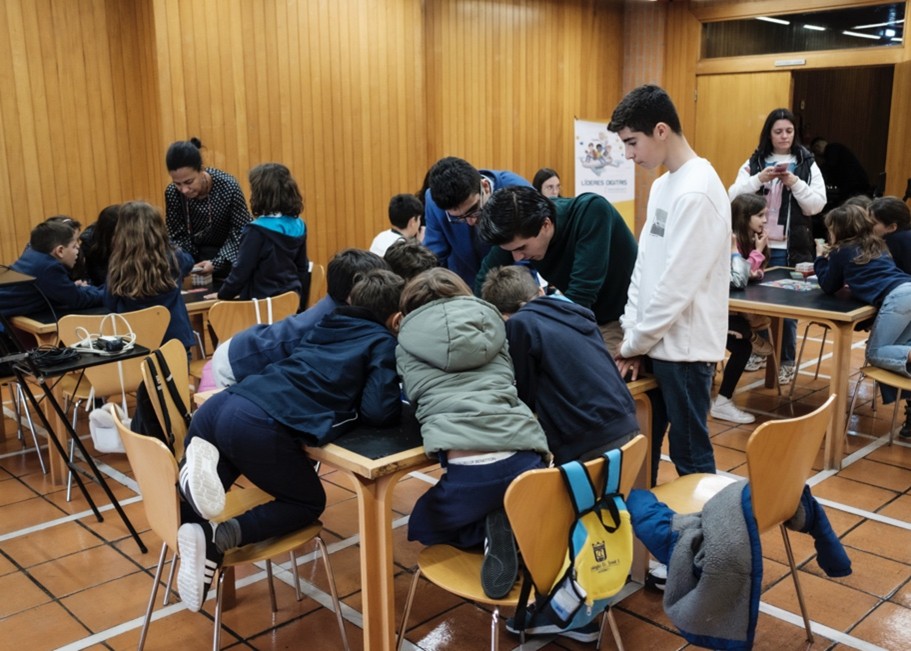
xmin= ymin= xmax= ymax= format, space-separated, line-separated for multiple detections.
xmin=57 ymin=305 xmax=171 ymax=398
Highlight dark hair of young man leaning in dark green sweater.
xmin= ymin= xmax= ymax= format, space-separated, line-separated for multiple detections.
xmin=477 ymin=185 xmax=557 ymax=246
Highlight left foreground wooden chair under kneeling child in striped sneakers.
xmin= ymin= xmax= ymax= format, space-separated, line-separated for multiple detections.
xmin=114 ymin=418 xmax=349 ymax=651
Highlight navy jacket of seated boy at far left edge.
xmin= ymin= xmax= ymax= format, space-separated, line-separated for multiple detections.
xmin=0 ymin=246 xmax=104 ymax=317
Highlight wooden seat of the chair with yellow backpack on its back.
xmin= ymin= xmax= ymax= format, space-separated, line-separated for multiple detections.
xmin=418 ymin=545 xmax=521 ymax=606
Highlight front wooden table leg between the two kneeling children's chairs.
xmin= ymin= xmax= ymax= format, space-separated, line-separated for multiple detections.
xmin=351 ymin=470 xmax=408 ymax=651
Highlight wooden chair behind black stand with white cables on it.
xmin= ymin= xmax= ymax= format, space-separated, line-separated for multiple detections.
xmin=57 ymin=305 xmax=171 ymax=501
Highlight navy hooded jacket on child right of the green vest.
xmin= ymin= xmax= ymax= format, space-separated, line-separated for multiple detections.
xmin=506 ymin=296 xmax=639 ymax=464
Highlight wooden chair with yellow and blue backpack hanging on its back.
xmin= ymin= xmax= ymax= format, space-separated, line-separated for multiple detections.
xmin=396 ymin=435 xmax=648 ymax=650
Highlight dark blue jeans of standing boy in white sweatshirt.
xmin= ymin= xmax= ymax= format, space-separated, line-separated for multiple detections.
xmin=651 ymin=359 xmax=715 ymax=483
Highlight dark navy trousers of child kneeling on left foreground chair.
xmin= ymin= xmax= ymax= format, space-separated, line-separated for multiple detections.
xmin=187 ymin=391 xmax=326 ymax=545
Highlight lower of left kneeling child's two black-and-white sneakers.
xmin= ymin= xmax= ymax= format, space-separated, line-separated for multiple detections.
xmin=177 ymin=522 xmax=225 ymax=612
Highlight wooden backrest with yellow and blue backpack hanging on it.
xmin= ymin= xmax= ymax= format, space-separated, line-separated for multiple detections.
xmin=504 ymin=435 xmax=648 ymax=590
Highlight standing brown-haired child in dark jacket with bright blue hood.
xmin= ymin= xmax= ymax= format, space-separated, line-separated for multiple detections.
xmin=217 ymin=163 xmax=310 ymax=309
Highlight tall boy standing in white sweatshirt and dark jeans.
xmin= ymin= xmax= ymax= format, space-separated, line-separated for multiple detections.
xmin=608 ymin=85 xmax=731 ymax=483
